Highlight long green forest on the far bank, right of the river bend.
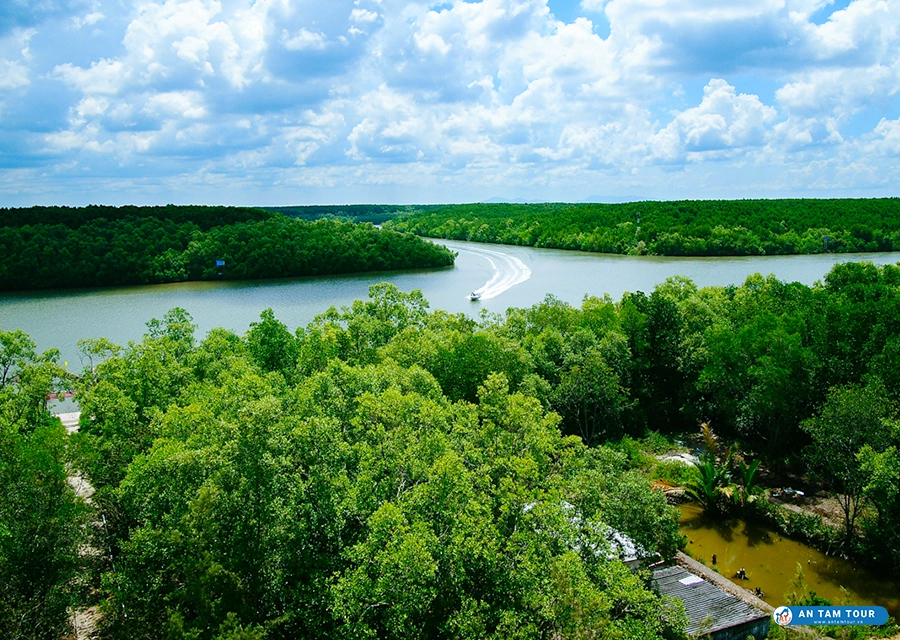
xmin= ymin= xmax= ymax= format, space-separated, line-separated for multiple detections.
xmin=385 ymin=198 xmax=900 ymax=256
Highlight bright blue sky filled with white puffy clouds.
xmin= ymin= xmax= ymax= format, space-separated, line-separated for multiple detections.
xmin=0 ymin=0 xmax=900 ymax=207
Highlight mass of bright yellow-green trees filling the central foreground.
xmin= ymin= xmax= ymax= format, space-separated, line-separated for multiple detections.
xmin=56 ymin=298 xmax=684 ymax=639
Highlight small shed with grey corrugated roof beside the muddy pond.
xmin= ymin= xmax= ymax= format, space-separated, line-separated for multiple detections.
xmin=652 ymin=567 xmax=771 ymax=640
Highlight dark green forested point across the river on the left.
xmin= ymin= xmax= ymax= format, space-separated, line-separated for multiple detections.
xmin=0 ymin=206 xmax=454 ymax=291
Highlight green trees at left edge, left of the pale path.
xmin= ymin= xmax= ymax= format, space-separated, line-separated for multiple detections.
xmin=0 ymin=331 xmax=85 ymax=640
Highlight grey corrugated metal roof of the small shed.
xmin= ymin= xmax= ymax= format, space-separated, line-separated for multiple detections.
xmin=653 ymin=567 xmax=769 ymax=636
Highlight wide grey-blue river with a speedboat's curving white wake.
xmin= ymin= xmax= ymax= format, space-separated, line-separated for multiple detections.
xmin=0 ymin=240 xmax=900 ymax=371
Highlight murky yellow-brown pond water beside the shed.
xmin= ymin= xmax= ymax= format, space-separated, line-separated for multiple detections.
xmin=681 ymin=503 xmax=900 ymax=620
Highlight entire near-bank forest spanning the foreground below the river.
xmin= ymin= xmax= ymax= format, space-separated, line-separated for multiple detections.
xmin=0 ymin=263 xmax=900 ymax=640
